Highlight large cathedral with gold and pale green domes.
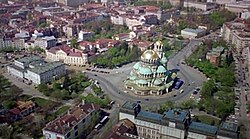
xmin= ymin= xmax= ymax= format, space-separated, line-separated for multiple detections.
xmin=125 ymin=41 xmax=176 ymax=96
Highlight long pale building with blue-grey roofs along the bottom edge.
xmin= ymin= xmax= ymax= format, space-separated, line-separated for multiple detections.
xmin=119 ymin=102 xmax=239 ymax=139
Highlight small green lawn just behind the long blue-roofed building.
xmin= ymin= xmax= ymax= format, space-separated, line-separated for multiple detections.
xmin=194 ymin=115 xmax=220 ymax=126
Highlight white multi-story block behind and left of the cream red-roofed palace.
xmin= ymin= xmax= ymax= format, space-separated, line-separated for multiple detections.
xmin=34 ymin=36 xmax=57 ymax=49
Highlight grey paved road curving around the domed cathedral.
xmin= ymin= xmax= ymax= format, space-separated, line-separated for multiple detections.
xmin=86 ymin=40 xmax=206 ymax=106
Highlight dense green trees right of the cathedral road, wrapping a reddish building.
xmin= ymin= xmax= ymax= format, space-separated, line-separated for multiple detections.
xmin=186 ymin=42 xmax=235 ymax=118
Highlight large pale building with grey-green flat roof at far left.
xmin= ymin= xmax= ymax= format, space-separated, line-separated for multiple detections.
xmin=7 ymin=56 xmax=66 ymax=84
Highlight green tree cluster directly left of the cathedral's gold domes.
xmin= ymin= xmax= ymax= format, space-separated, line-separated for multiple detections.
xmin=90 ymin=42 xmax=141 ymax=68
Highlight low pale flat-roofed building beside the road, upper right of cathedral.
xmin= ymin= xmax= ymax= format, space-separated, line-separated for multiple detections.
xmin=181 ymin=28 xmax=206 ymax=39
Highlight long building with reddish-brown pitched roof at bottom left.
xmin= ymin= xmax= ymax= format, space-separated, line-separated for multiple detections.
xmin=43 ymin=104 xmax=100 ymax=139
